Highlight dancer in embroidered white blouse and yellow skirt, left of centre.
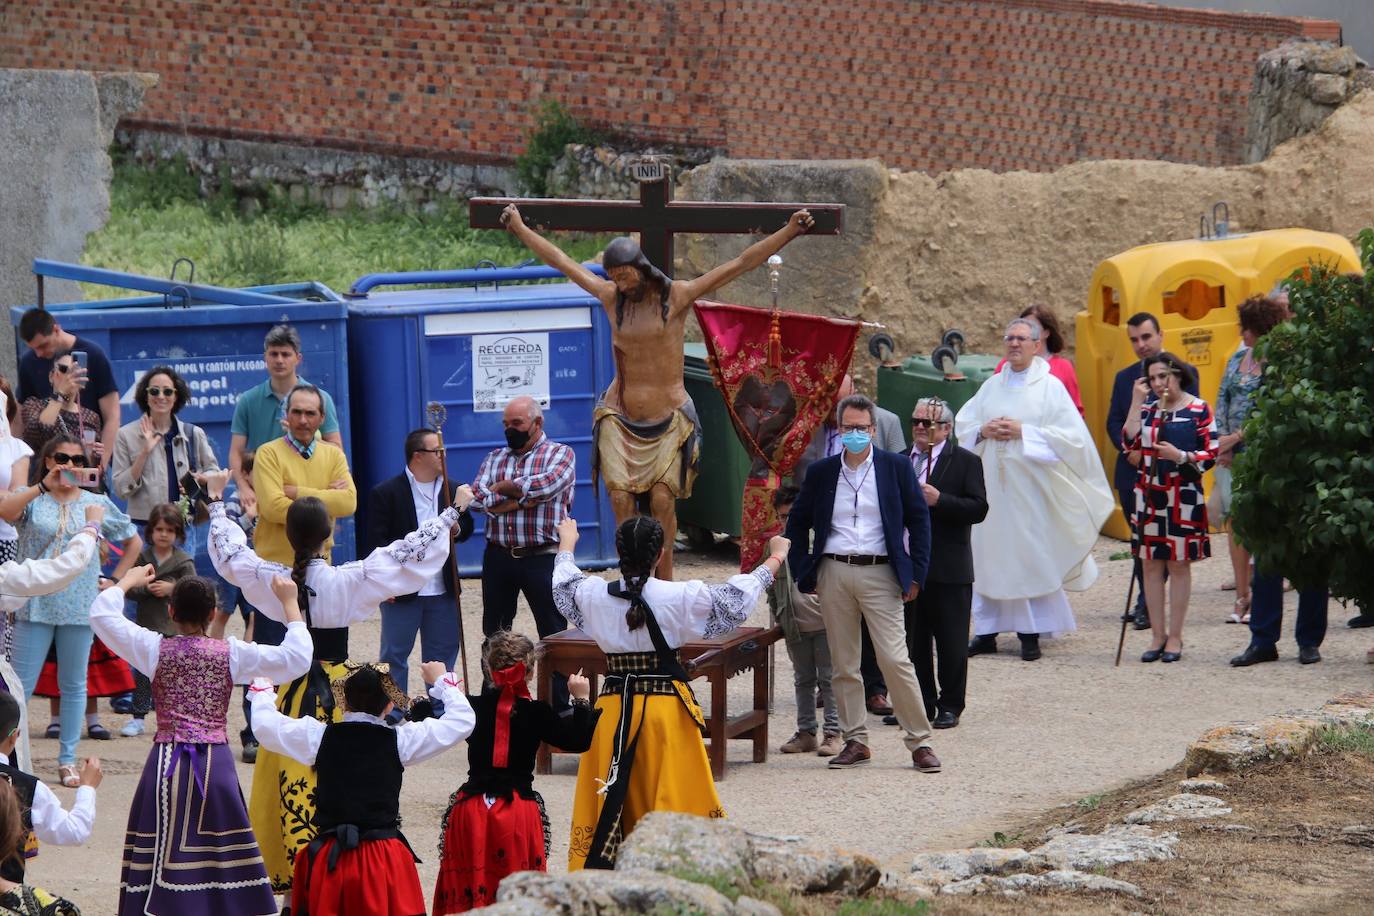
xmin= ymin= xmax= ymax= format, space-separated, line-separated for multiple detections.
xmin=205 ymin=471 xmax=473 ymax=894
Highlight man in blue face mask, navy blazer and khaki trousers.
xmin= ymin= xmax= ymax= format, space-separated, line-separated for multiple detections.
xmin=787 ymin=394 xmax=940 ymax=773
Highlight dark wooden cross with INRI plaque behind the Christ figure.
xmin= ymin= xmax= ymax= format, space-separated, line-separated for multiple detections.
xmin=467 ymin=163 xmax=845 ymax=277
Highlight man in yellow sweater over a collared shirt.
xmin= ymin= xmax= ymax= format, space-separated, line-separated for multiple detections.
xmin=253 ymin=385 xmax=357 ymax=566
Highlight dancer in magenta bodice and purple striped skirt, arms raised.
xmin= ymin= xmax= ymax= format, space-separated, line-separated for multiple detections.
xmin=91 ymin=566 xmax=311 ymax=916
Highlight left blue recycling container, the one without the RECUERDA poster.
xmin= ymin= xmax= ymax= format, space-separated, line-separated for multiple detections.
xmin=10 ymin=261 xmax=356 ymax=573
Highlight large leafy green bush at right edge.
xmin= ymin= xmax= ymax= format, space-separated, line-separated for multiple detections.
xmin=1232 ymin=229 xmax=1374 ymax=607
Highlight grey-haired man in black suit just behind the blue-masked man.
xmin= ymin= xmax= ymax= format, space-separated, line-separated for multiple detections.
xmin=883 ymin=398 xmax=988 ymax=728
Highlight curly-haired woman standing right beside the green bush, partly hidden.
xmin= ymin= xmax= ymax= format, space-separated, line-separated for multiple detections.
xmin=1212 ymin=295 xmax=1287 ymax=623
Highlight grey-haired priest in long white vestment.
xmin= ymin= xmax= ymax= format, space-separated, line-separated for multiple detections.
xmin=955 ymin=319 xmax=1113 ymax=661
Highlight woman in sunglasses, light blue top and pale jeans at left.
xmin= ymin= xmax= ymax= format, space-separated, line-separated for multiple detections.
xmin=0 ymin=435 xmax=143 ymax=788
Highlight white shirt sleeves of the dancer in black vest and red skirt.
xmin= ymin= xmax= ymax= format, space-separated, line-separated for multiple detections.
xmin=249 ymin=672 xmax=477 ymax=766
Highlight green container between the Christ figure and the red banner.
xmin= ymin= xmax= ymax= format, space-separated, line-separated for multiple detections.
xmin=677 ymin=342 xmax=750 ymax=547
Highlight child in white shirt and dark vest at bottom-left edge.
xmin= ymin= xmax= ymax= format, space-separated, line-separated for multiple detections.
xmin=0 ymin=692 xmax=102 ymax=884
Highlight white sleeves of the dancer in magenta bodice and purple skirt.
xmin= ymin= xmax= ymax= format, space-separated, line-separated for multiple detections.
xmin=91 ymin=585 xmax=313 ymax=684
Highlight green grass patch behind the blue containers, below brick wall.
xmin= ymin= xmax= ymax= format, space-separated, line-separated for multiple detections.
xmin=82 ymin=161 xmax=605 ymax=299
